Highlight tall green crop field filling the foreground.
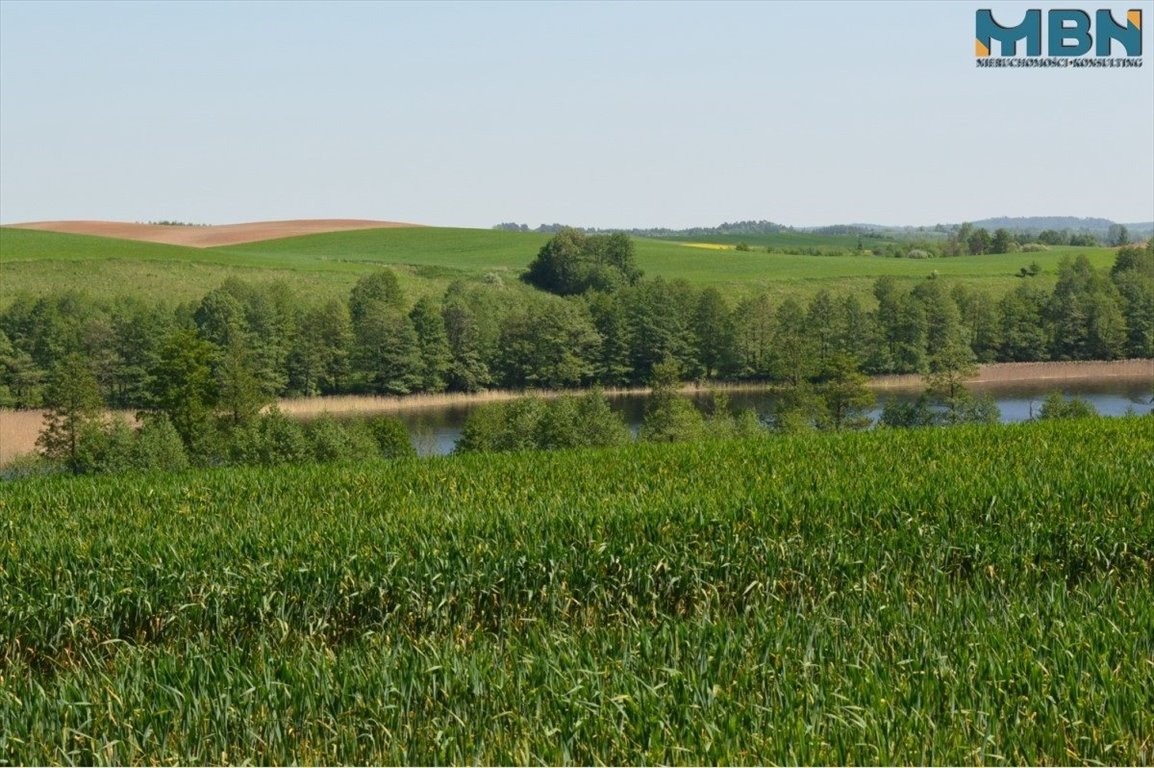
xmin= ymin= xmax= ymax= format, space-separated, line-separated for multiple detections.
xmin=0 ymin=417 xmax=1154 ymax=765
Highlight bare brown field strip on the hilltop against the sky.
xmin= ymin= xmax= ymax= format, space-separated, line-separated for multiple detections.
xmin=8 ymin=219 xmax=420 ymax=248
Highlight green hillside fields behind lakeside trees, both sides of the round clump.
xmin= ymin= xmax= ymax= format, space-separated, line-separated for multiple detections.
xmin=0 ymin=222 xmax=1114 ymax=307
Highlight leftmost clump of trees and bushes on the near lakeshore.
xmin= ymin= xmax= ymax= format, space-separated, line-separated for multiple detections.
xmin=37 ymin=341 xmax=414 ymax=474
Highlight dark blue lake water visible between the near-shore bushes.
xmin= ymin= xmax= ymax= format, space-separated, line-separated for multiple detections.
xmin=399 ymin=379 xmax=1154 ymax=455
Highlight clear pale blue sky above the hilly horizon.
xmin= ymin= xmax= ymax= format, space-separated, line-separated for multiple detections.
xmin=0 ymin=0 xmax=1154 ymax=227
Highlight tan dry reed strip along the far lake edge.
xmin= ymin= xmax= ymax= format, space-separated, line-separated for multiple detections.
xmin=0 ymin=359 xmax=1154 ymax=466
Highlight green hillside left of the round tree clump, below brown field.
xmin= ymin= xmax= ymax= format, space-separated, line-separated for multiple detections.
xmin=0 ymin=227 xmax=546 ymax=306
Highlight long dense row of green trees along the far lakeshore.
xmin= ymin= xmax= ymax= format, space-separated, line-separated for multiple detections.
xmin=0 ymin=241 xmax=1154 ymax=419
